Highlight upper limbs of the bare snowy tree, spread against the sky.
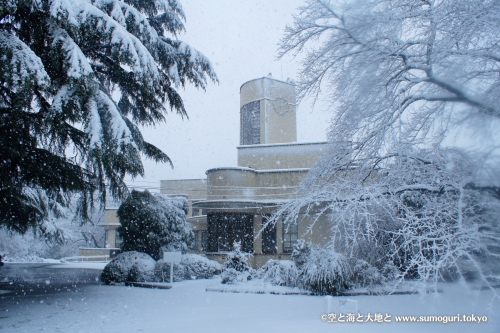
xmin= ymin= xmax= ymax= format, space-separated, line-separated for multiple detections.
xmin=280 ymin=0 xmax=500 ymax=154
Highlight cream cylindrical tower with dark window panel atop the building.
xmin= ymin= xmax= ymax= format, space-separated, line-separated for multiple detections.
xmin=240 ymin=77 xmax=297 ymax=145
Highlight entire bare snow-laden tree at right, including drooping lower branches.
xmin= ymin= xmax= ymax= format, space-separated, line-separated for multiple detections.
xmin=276 ymin=0 xmax=500 ymax=296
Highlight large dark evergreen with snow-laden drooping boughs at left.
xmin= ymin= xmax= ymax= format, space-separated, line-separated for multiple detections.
xmin=0 ymin=0 xmax=217 ymax=233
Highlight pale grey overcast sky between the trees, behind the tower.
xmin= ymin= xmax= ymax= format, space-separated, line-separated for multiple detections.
xmin=127 ymin=0 xmax=331 ymax=191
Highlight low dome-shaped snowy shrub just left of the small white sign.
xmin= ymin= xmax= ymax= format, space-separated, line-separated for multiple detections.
xmin=101 ymin=251 xmax=155 ymax=284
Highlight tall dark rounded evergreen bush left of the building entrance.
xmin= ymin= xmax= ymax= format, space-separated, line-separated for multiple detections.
xmin=117 ymin=190 xmax=194 ymax=260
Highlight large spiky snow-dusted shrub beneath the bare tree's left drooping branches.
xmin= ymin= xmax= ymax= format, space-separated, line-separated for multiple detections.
xmin=292 ymin=241 xmax=352 ymax=295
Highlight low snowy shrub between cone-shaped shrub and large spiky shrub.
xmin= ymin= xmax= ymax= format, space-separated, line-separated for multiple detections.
xmin=256 ymin=259 xmax=299 ymax=287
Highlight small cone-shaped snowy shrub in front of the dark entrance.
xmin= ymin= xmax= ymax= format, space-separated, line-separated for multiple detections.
xmin=221 ymin=242 xmax=253 ymax=284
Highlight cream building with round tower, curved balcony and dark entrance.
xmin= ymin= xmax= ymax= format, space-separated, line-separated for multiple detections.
xmin=161 ymin=77 xmax=330 ymax=267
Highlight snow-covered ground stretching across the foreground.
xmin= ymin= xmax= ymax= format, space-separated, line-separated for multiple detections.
xmin=0 ymin=270 xmax=500 ymax=333
